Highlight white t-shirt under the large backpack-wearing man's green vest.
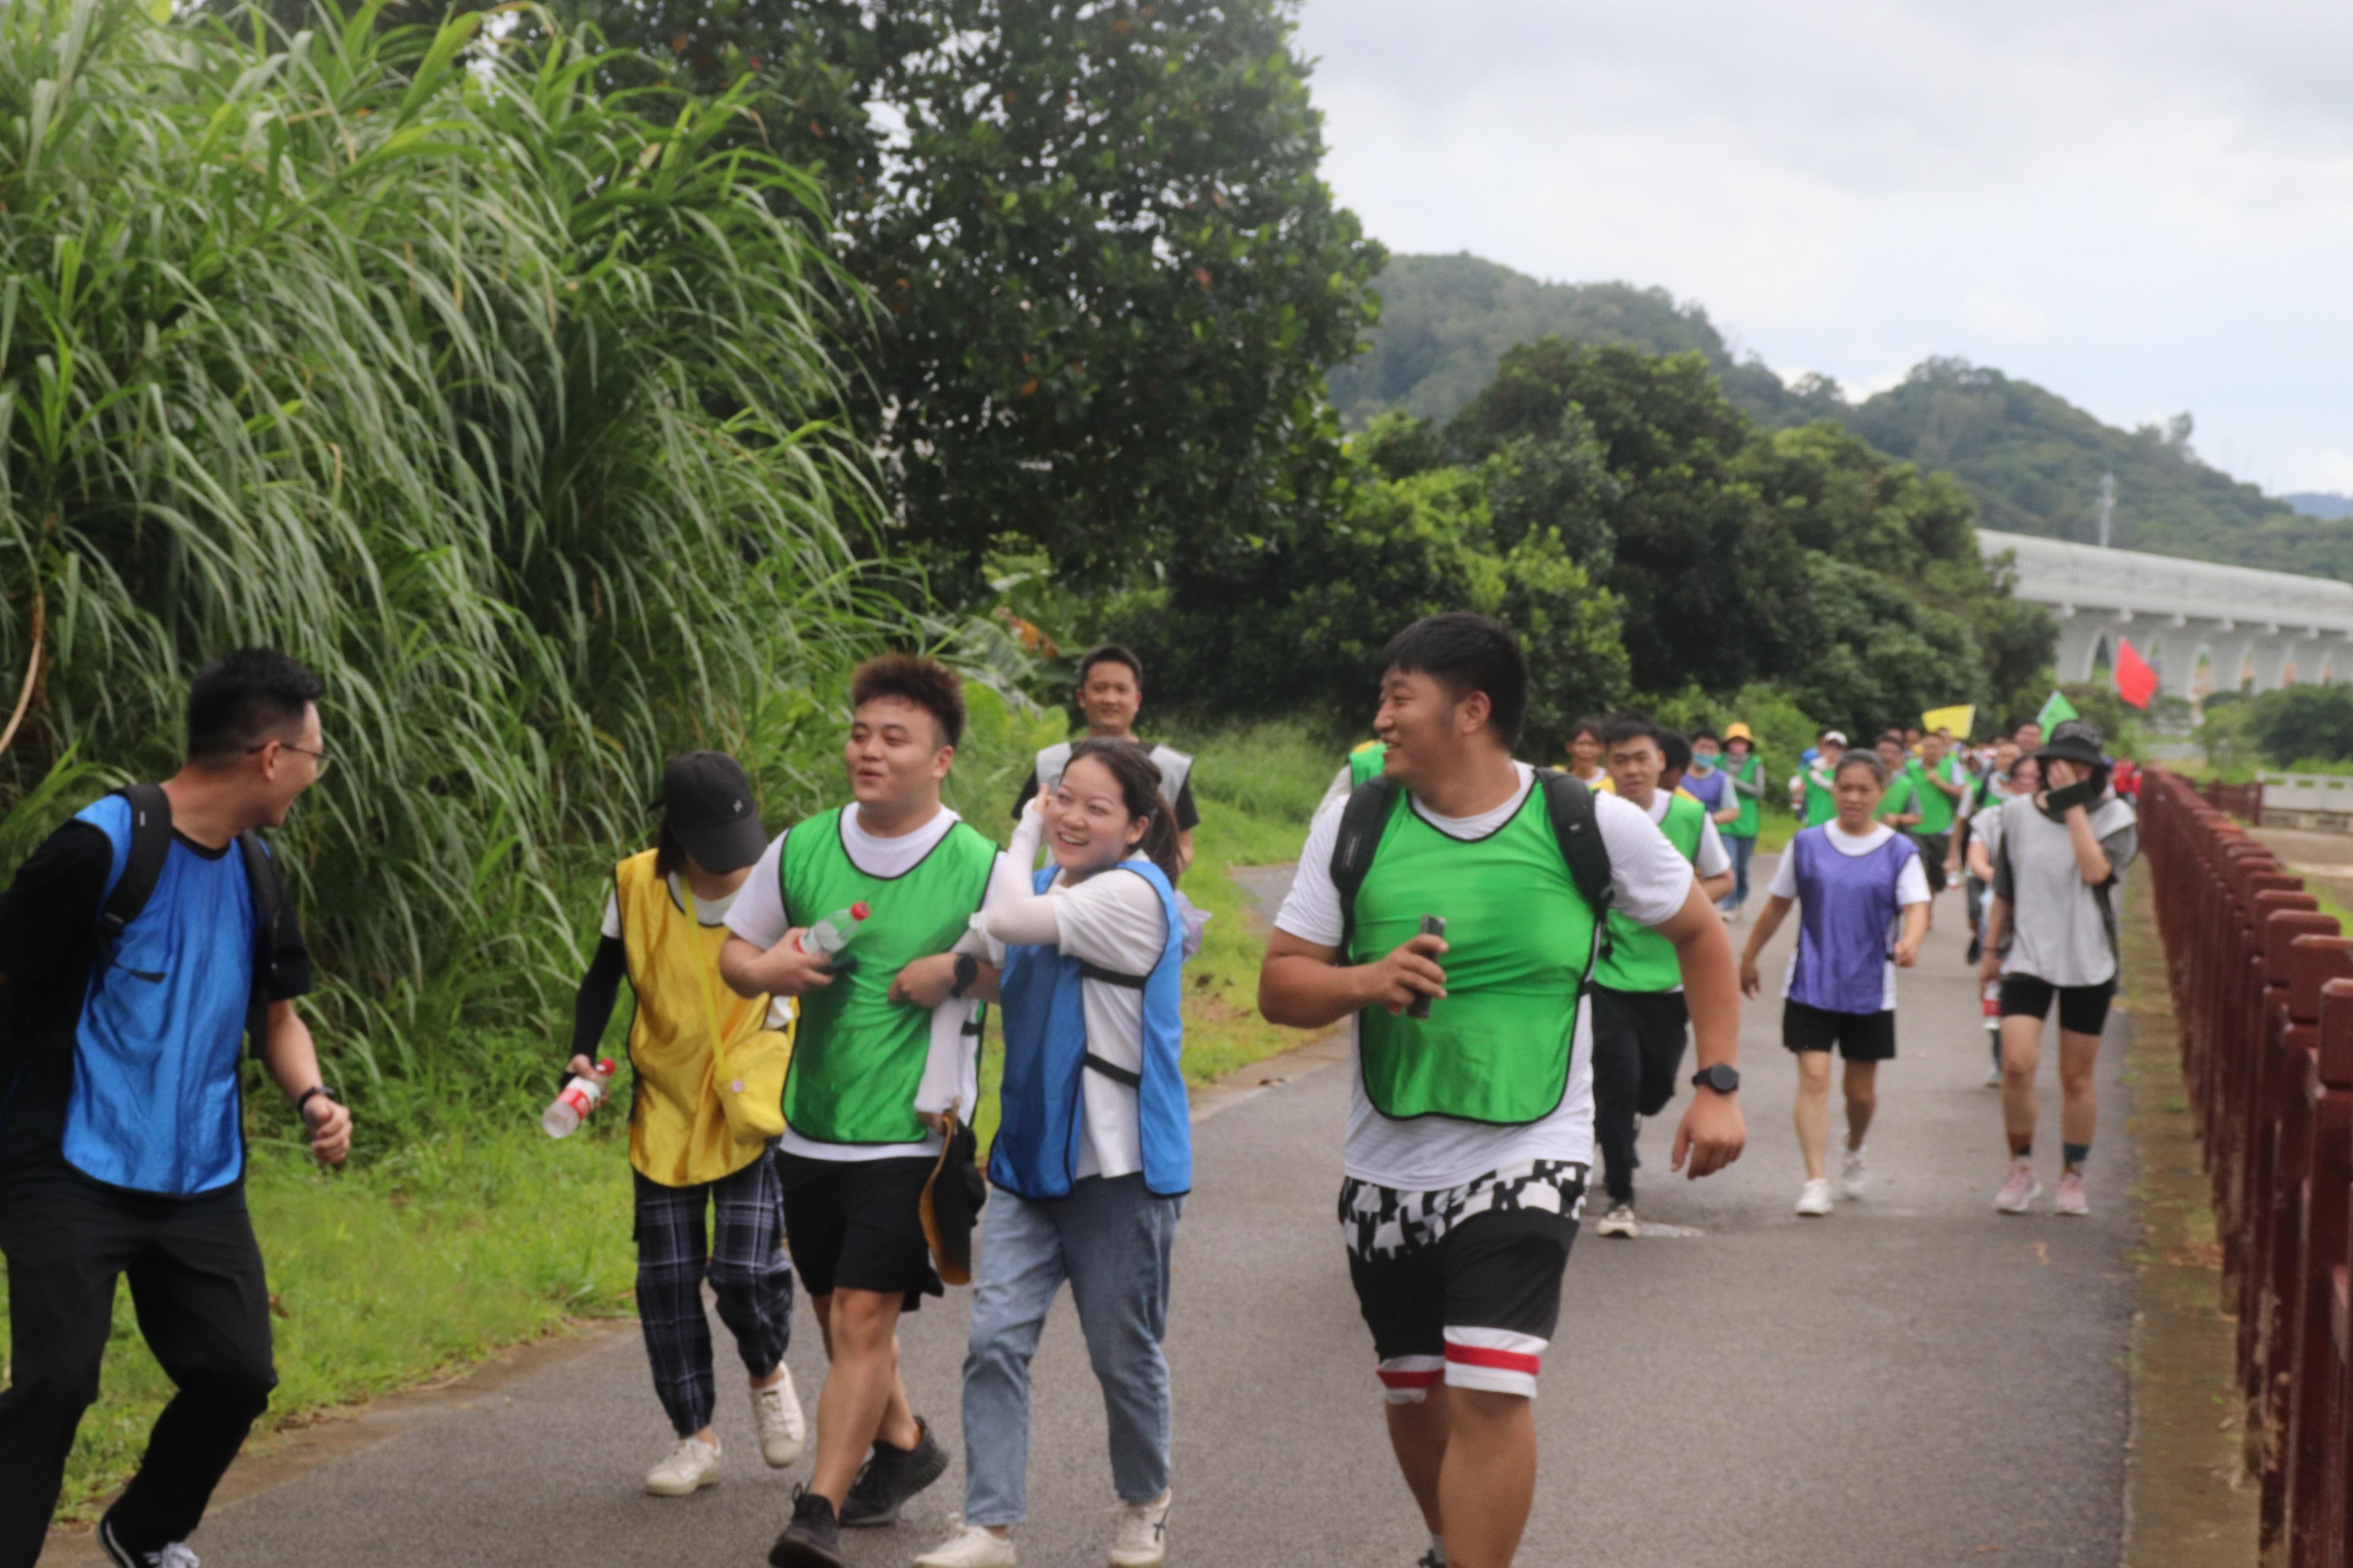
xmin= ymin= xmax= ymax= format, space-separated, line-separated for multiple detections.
xmin=1275 ymin=762 xmax=1692 ymax=1192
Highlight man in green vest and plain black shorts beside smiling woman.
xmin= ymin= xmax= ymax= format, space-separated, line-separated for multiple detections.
xmin=720 ymin=654 xmax=1002 ymax=1568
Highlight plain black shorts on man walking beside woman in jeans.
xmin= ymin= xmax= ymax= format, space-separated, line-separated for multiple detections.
xmin=776 ymin=1152 xmax=944 ymax=1312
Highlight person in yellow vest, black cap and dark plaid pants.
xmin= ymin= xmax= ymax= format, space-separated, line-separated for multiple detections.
xmin=570 ymin=752 xmax=807 ymax=1497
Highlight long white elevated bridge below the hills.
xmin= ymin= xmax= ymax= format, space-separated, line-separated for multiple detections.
xmin=1977 ymin=529 xmax=2353 ymax=698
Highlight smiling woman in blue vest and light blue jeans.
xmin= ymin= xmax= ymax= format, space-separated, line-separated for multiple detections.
xmin=915 ymin=740 xmax=1193 ymax=1568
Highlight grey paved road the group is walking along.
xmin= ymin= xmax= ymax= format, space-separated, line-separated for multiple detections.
xmin=64 ymin=860 xmax=2132 ymax=1568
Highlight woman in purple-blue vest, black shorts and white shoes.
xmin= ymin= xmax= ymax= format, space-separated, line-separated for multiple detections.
xmin=1741 ymin=750 xmax=1927 ymax=1218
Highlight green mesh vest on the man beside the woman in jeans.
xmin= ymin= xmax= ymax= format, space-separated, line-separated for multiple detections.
xmin=779 ymin=806 xmax=998 ymax=1143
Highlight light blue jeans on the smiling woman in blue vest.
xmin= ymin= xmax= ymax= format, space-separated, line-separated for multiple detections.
xmin=965 ymin=1175 xmax=1183 ymax=1528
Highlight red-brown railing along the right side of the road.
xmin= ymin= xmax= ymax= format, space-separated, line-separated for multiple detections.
xmin=2141 ymin=771 xmax=2353 ymax=1568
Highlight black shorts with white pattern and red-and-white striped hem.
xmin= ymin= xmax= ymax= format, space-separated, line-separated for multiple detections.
xmin=1339 ymin=1161 xmax=1586 ymax=1404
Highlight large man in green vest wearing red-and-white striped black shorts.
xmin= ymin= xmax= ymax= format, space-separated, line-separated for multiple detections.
xmin=1259 ymin=613 xmax=1746 ymax=1568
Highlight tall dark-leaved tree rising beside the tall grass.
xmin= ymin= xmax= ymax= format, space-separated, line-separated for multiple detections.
xmin=565 ymin=0 xmax=1381 ymax=593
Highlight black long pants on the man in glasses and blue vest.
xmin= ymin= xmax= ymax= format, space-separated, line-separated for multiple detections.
xmin=0 ymin=1171 xmax=278 ymax=1568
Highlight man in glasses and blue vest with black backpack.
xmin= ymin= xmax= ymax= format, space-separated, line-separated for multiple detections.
xmin=0 ymin=649 xmax=351 ymax=1568
